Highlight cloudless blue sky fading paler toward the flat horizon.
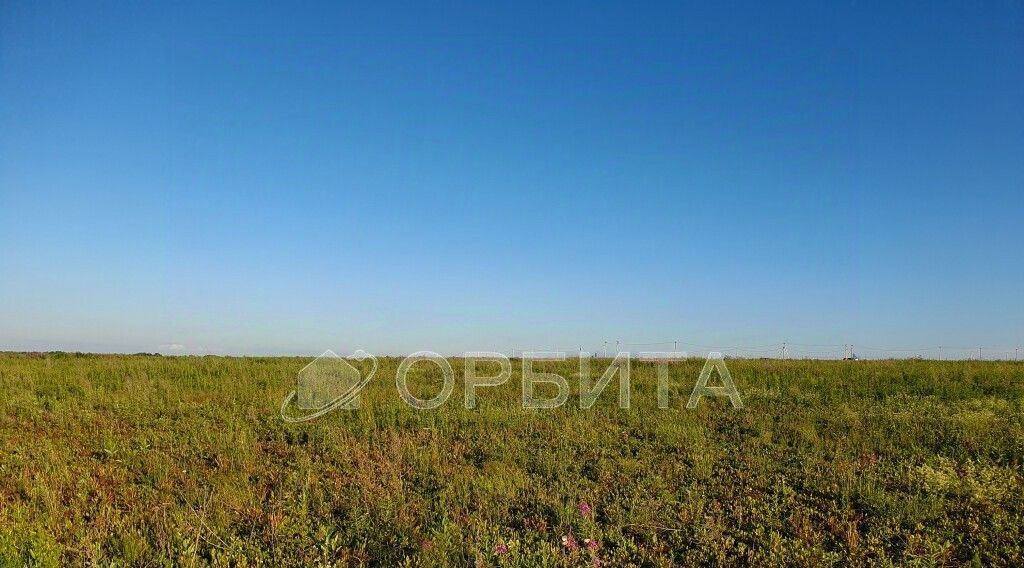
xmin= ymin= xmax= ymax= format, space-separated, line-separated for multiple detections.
xmin=0 ymin=0 xmax=1024 ymax=353
